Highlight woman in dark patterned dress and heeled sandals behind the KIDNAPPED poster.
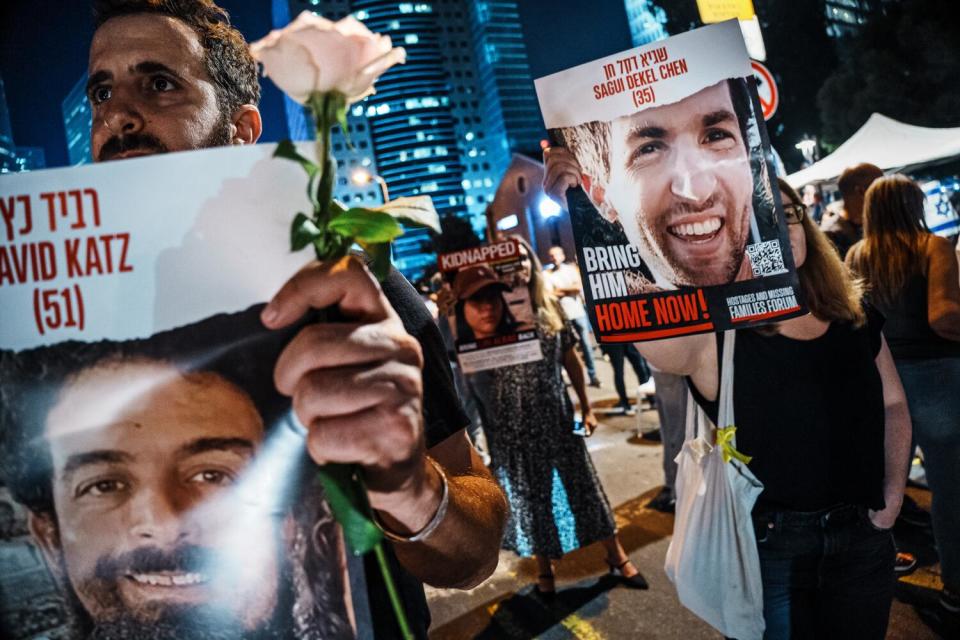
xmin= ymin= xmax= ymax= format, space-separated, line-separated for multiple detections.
xmin=467 ymin=239 xmax=647 ymax=597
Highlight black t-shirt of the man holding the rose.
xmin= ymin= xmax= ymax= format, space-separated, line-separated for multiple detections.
xmin=364 ymin=269 xmax=469 ymax=640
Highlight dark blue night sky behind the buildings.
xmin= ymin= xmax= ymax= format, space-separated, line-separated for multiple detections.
xmin=0 ymin=0 xmax=630 ymax=166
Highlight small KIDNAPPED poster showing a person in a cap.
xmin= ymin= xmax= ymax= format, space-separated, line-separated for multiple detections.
xmin=437 ymin=239 xmax=543 ymax=373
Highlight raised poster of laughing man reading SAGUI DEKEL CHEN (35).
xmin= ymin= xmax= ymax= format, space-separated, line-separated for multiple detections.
xmin=535 ymin=20 xmax=806 ymax=342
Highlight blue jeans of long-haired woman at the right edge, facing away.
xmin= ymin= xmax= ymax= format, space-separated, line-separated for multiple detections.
xmin=896 ymin=358 xmax=960 ymax=591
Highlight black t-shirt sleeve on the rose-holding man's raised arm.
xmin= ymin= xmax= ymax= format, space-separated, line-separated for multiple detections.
xmin=380 ymin=268 xmax=470 ymax=448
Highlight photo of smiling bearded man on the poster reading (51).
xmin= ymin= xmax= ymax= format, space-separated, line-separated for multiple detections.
xmin=0 ymin=305 xmax=354 ymax=640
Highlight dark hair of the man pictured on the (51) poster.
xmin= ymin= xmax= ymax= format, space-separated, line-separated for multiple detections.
xmin=0 ymin=305 xmax=302 ymax=515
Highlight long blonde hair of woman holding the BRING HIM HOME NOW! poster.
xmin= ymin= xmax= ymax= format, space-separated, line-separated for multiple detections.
xmin=777 ymin=178 xmax=866 ymax=327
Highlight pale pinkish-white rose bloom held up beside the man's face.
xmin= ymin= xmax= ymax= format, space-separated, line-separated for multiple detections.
xmin=250 ymin=11 xmax=407 ymax=104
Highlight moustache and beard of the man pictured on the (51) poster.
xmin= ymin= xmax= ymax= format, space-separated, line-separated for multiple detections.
xmin=74 ymin=545 xmax=293 ymax=640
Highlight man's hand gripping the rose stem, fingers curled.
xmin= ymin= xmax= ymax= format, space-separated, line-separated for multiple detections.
xmin=262 ymin=256 xmax=440 ymax=533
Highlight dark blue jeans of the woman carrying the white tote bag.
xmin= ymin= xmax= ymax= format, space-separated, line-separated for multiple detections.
xmin=753 ymin=506 xmax=896 ymax=640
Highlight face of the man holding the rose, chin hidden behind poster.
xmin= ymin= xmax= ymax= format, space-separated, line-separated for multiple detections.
xmin=87 ymin=14 xmax=231 ymax=162
